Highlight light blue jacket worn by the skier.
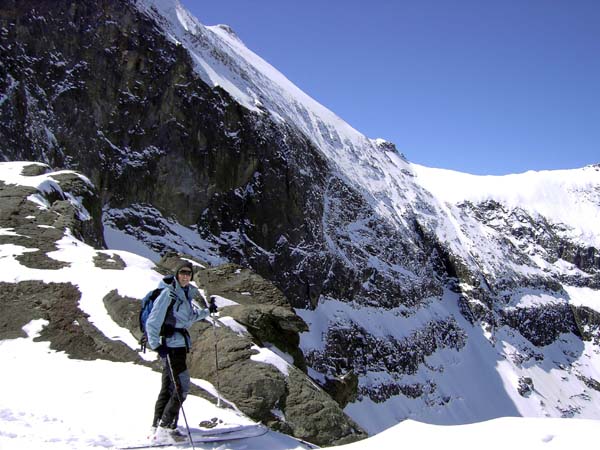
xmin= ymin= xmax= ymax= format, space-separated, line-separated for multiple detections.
xmin=146 ymin=277 xmax=210 ymax=349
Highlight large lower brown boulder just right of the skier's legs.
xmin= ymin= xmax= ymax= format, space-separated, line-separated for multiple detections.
xmin=190 ymin=318 xmax=366 ymax=445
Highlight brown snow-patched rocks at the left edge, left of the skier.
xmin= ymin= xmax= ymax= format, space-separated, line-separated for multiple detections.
xmin=0 ymin=164 xmax=137 ymax=361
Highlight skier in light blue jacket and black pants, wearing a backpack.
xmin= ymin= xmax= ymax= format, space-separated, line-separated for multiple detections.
xmin=146 ymin=262 xmax=217 ymax=443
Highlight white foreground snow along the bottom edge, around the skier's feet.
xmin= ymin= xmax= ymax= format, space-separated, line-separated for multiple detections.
xmin=0 ymin=320 xmax=600 ymax=450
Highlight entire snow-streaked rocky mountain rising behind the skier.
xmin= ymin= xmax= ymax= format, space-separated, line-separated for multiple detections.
xmin=0 ymin=0 xmax=600 ymax=442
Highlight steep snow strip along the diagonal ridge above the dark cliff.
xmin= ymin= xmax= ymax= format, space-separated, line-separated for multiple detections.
xmin=138 ymin=0 xmax=436 ymax=236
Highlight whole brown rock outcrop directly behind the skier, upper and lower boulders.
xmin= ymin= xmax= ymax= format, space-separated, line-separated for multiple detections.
xmin=104 ymin=253 xmax=366 ymax=445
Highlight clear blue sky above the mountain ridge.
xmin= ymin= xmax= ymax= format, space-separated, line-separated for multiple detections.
xmin=181 ymin=0 xmax=600 ymax=174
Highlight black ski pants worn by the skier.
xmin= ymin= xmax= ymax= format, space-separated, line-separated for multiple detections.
xmin=152 ymin=347 xmax=190 ymax=428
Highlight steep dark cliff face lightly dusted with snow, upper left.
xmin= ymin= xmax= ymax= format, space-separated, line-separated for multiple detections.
xmin=0 ymin=1 xmax=440 ymax=307
